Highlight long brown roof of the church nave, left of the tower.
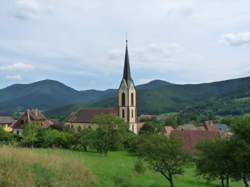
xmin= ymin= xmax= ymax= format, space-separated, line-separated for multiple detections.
xmin=65 ymin=108 xmax=118 ymax=123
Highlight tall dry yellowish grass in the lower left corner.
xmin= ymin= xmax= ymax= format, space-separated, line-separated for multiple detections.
xmin=0 ymin=147 xmax=98 ymax=187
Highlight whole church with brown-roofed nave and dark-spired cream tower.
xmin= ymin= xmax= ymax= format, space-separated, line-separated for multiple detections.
xmin=65 ymin=40 xmax=139 ymax=134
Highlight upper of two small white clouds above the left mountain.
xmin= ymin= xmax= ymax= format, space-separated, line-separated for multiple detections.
xmin=0 ymin=62 xmax=35 ymax=72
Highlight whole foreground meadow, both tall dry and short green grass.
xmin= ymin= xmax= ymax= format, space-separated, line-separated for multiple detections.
xmin=0 ymin=147 xmax=243 ymax=187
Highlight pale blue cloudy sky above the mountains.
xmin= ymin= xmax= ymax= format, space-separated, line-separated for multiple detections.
xmin=0 ymin=0 xmax=250 ymax=90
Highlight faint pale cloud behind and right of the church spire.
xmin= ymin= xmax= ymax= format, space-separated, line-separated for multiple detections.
xmin=106 ymin=43 xmax=203 ymax=72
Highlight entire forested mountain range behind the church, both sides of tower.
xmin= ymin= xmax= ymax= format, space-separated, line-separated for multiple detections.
xmin=0 ymin=77 xmax=250 ymax=115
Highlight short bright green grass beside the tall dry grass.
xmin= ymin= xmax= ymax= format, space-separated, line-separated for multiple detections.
xmin=35 ymin=149 xmax=243 ymax=187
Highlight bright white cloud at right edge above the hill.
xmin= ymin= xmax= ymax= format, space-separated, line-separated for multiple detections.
xmin=223 ymin=32 xmax=250 ymax=46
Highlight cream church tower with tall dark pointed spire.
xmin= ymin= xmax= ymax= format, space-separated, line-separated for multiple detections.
xmin=118 ymin=40 xmax=138 ymax=134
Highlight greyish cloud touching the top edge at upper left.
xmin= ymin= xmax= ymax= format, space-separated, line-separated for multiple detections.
xmin=11 ymin=0 xmax=42 ymax=20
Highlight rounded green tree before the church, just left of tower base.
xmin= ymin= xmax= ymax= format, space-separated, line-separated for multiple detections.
xmin=93 ymin=114 xmax=128 ymax=156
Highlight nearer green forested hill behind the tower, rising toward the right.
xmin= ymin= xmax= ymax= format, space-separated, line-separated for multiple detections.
xmin=48 ymin=77 xmax=250 ymax=115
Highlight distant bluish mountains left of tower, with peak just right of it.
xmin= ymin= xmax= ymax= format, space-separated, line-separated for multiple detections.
xmin=0 ymin=80 xmax=170 ymax=115
